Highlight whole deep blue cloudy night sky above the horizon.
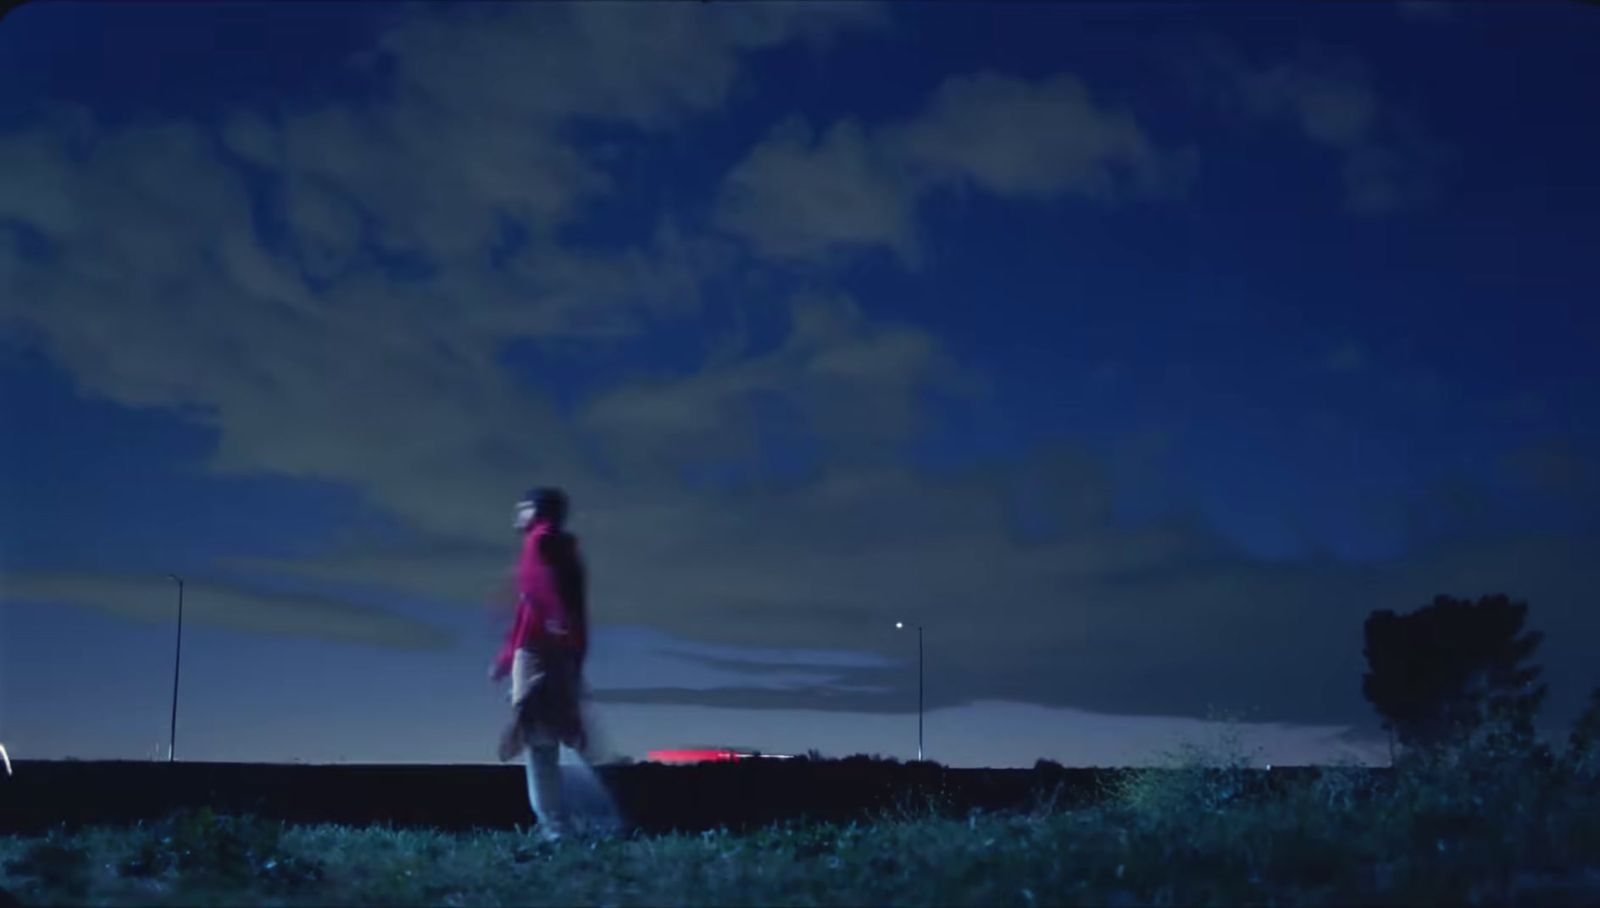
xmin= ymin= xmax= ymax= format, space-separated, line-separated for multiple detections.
xmin=0 ymin=2 xmax=1600 ymax=766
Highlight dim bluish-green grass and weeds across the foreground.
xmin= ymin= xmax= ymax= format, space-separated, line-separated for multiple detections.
xmin=0 ymin=740 xmax=1600 ymax=905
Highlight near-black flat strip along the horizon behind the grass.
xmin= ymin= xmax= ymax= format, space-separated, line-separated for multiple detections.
xmin=0 ymin=758 xmax=1314 ymax=833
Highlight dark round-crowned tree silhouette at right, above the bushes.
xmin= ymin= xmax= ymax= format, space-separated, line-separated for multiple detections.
xmin=1362 ymin=595 xmax=1546 ymax=748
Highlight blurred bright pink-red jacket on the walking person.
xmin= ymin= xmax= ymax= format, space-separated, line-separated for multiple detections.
xmin=494 ymin=523 xmax=589 ymax=675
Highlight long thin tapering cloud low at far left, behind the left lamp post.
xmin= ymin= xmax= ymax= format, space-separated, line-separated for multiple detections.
xmin=0 ymin=571 xmax=453 ymax=649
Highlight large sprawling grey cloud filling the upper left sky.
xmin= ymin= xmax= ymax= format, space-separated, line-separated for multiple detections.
xmin=0 ymin=5 xmax=877 ymax=553
